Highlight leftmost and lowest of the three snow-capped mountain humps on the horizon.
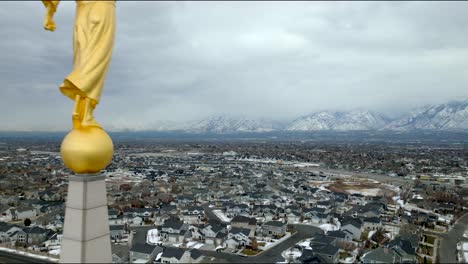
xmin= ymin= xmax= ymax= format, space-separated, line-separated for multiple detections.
xmin=185 ymin=115 xmax=275 ymax=133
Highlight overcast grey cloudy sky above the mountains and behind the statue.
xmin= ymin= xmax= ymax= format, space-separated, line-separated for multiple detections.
xmin=0 ymin=1 xmax=468 ymax=130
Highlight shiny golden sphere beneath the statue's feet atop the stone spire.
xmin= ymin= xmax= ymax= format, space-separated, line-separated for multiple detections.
xmin=60 ymin=127 xmax=114 ymax=173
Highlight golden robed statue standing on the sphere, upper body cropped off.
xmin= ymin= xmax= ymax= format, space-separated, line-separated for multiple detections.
xmin=42 ymin=0 xmax=115 ymax=128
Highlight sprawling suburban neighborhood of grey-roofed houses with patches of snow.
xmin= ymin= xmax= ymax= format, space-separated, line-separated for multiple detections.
xmin=0 ymin=138 xmax=468 ymax=263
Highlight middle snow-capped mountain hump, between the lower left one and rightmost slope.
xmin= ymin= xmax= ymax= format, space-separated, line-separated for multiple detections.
xmin=286 ymin=110 xmax=388 ymax=131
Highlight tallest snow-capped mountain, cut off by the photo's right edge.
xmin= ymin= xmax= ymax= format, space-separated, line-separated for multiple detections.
xmin=384 ymin=100 xmax=468 ymax=130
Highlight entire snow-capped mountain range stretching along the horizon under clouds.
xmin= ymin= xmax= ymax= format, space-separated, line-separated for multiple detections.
xmin=113 ymin=100 xmax=468 ymax=133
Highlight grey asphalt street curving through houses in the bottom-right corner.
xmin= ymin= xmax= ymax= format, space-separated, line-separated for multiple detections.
xmin=439 ymin=214 xmax=468 ymax=263
